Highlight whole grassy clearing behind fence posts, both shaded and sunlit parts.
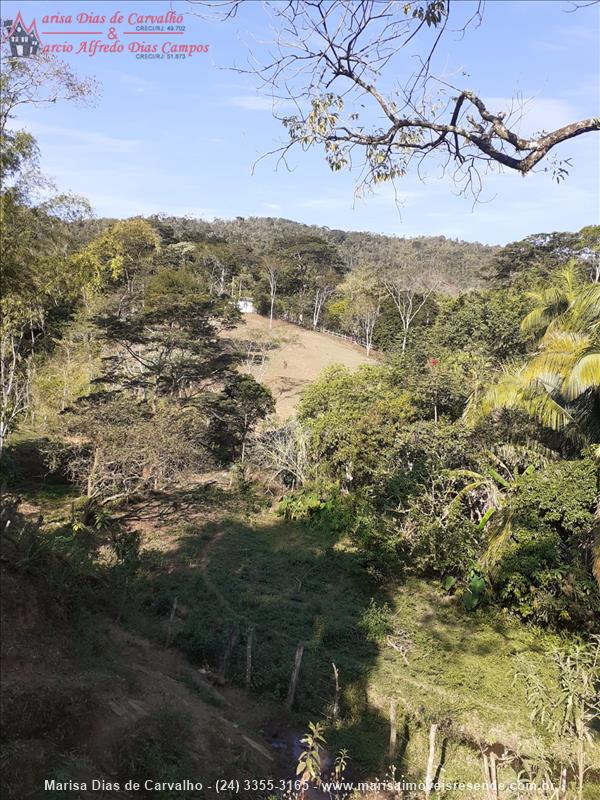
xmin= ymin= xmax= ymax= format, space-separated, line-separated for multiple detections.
xmin=125 ymin=506 xmax=580 ymax=796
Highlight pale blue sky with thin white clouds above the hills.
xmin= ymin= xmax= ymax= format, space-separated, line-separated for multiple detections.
xmin=2 ymin=0 xmax=600 ymax=244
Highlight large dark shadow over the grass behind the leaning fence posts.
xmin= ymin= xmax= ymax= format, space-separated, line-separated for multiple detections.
xmin=129 ymin=506 xmax=400 ymax=770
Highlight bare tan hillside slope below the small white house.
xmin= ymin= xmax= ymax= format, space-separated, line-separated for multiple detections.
xmin=228 ymin=314 xmax=375 ymax=418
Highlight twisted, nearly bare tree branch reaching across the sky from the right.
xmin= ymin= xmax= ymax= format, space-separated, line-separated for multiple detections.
xmin=190 ymin=0 xmax=600 ymax=199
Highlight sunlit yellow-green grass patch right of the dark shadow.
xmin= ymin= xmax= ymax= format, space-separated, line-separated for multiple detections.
xmin=372 ymin=580 xmax=556 ymax=747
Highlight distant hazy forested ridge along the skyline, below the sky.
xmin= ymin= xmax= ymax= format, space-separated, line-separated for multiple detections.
xmin=78 ymin=214 xmax=599 ymax=294
